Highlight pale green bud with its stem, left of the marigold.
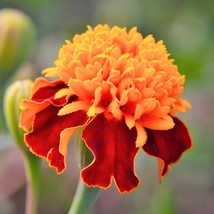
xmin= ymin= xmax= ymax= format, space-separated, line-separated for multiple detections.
xmin=4 ymin=80 xmax=41 ymax=214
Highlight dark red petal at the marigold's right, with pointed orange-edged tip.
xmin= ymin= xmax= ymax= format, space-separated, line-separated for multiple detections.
xmin=143 ymin=117 xmax=192 ymax=180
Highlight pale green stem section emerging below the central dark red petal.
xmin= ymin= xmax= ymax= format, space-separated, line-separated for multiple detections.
xmin=68 ymin=179 xmax=101 ymax=214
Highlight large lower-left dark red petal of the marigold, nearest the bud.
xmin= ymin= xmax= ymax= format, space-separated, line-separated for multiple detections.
xmin=25 ymin=105 xmax=88 ymax=173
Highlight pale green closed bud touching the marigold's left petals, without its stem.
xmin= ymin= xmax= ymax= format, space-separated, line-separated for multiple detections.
xmin=4 ymin=79 xmax=32 ymax=152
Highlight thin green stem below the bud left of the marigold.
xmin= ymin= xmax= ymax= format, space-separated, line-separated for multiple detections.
xmin=25 ymin=153 xmax=41 ymax=214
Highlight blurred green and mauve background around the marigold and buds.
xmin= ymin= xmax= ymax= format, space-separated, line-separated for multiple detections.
xmin=0 ymin=0 xmax=214 ymax=214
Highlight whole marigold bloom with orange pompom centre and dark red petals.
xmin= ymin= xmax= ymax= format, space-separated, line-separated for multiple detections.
xmin=20 ymin=25 xmax=191 ymax=193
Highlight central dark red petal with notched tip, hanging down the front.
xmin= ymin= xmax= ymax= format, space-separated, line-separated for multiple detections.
xmin=81 ymin=114 xmax=139 ymax=193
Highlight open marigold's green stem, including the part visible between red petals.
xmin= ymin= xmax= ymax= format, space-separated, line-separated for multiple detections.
xmin=68 ymin=128 xmax=101 ymax=214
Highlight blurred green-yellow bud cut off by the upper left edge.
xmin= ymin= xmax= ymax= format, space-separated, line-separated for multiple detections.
xmin=0 ymin=8 xmax=36 ymax=75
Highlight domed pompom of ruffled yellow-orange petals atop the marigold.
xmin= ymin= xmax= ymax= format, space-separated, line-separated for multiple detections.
xmin=44 ymin=25 xmax=190 ymax=123
